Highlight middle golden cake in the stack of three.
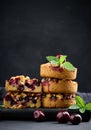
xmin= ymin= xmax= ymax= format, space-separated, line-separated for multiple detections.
xmin=41 ymin=78 xmax=78 ymax=93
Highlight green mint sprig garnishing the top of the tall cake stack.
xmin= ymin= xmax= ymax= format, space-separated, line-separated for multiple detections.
xmin=46 ymin=55 xmax=74 ymax=71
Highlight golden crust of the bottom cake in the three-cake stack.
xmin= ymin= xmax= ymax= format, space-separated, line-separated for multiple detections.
xmin=42 ymin=94 xmax=76 ymax=108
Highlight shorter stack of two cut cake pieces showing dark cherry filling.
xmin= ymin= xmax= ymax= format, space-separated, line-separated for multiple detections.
xmin=4 ymin=75 xmax=42 ymax=109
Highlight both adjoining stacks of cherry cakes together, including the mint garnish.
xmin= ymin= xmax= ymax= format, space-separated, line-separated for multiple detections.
xmin=4 ymin=55 xmax=78 ymax=109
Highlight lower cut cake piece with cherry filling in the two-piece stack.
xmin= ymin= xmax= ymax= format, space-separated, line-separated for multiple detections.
xmin=3 ymin=92 xmax=41 ymax=109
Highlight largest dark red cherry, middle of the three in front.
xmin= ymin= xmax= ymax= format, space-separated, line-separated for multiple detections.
xmin=56 ymin=111 xmax=70 ymax=123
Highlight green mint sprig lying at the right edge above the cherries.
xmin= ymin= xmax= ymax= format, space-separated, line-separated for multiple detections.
xmin=69 ymin=96 xmax=91 ymax=113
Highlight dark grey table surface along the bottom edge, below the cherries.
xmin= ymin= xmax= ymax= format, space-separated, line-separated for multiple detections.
xmin=0 ymin=120 xmax=91 ymax=130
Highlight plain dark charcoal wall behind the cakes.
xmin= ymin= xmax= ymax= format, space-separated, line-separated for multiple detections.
xmin=0 ymin=0 xmax=91 ymax=92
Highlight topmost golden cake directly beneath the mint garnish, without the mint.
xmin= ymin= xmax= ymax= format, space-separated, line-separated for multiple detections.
xmin=40 ymin=62 xmax=77 ymax=80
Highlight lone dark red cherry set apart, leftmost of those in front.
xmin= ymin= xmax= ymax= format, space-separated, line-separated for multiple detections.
xmin=33 ymin=110 xmax=45 ymax=121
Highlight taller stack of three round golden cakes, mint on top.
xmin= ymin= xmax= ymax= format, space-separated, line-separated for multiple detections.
xmin=40 ymin=56 xmax=78 ymax=108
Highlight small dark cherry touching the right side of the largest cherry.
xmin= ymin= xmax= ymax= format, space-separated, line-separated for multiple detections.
xmin=70 ymin=114 xmax=82 ymax=125
